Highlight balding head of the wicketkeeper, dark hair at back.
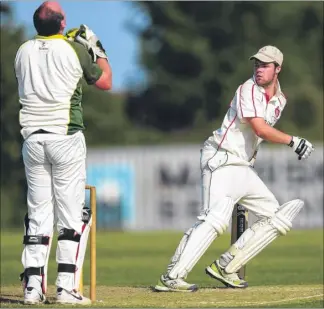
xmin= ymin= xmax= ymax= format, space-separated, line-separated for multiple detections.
xmin=33 ymin=1 xmax=65 ymax=36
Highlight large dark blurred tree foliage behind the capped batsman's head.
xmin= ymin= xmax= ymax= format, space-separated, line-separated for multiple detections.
xmin=127 ymin=1 xmax=324 ymax=138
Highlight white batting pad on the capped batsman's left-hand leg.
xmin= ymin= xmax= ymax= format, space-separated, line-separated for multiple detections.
xmin=168 ymin=197 xmax=234 ymax=279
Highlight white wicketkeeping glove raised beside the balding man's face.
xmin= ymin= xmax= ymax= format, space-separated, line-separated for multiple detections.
xmin=74 ymin=24 xmax=108 ymax=62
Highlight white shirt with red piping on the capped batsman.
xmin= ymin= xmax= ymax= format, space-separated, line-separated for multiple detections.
xmin=208 ymin=77 xmax=287 ymax=161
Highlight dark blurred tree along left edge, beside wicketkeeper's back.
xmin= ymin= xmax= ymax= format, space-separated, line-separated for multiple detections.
xmin=0 ymin=2 xmax=25 ymax=227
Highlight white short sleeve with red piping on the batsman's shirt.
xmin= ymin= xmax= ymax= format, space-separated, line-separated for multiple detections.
xmin=237 ymin=82 xmax=265 ymax=119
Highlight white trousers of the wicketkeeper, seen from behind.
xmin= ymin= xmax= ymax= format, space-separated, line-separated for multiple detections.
xmin=22 ymin=131 xmax=86 ymax=285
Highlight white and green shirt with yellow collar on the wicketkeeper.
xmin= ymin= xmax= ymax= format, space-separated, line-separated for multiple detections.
xmin=14 ymin=35 xmax=102 ymax=139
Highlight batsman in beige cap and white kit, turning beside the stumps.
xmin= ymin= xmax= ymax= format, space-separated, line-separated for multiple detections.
xmin=155 ymin=45 xmax=314 ymax=292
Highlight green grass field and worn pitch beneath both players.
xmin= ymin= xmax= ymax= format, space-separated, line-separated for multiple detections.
xmin=1 ymin=230 xmax=324 ymax=308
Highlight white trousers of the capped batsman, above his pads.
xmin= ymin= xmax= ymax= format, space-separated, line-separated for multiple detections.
xmin=200 ymin=145 xmax=279 ymax=218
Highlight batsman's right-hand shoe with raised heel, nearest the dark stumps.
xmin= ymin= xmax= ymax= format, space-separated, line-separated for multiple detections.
xmin=206 ymin=260 xmax=248 ymax=288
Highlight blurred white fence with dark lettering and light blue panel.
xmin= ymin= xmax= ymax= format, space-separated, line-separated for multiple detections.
xmin=87 ymin=145 xmax=323 ymax=231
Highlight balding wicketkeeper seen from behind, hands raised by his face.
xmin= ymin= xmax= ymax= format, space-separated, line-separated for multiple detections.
xmin=14 ymin=1 xmax=112 ymax=304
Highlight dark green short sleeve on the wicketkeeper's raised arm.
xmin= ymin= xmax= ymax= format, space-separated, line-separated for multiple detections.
xmin=68 ymin=41 xmax=102 ymax=85
